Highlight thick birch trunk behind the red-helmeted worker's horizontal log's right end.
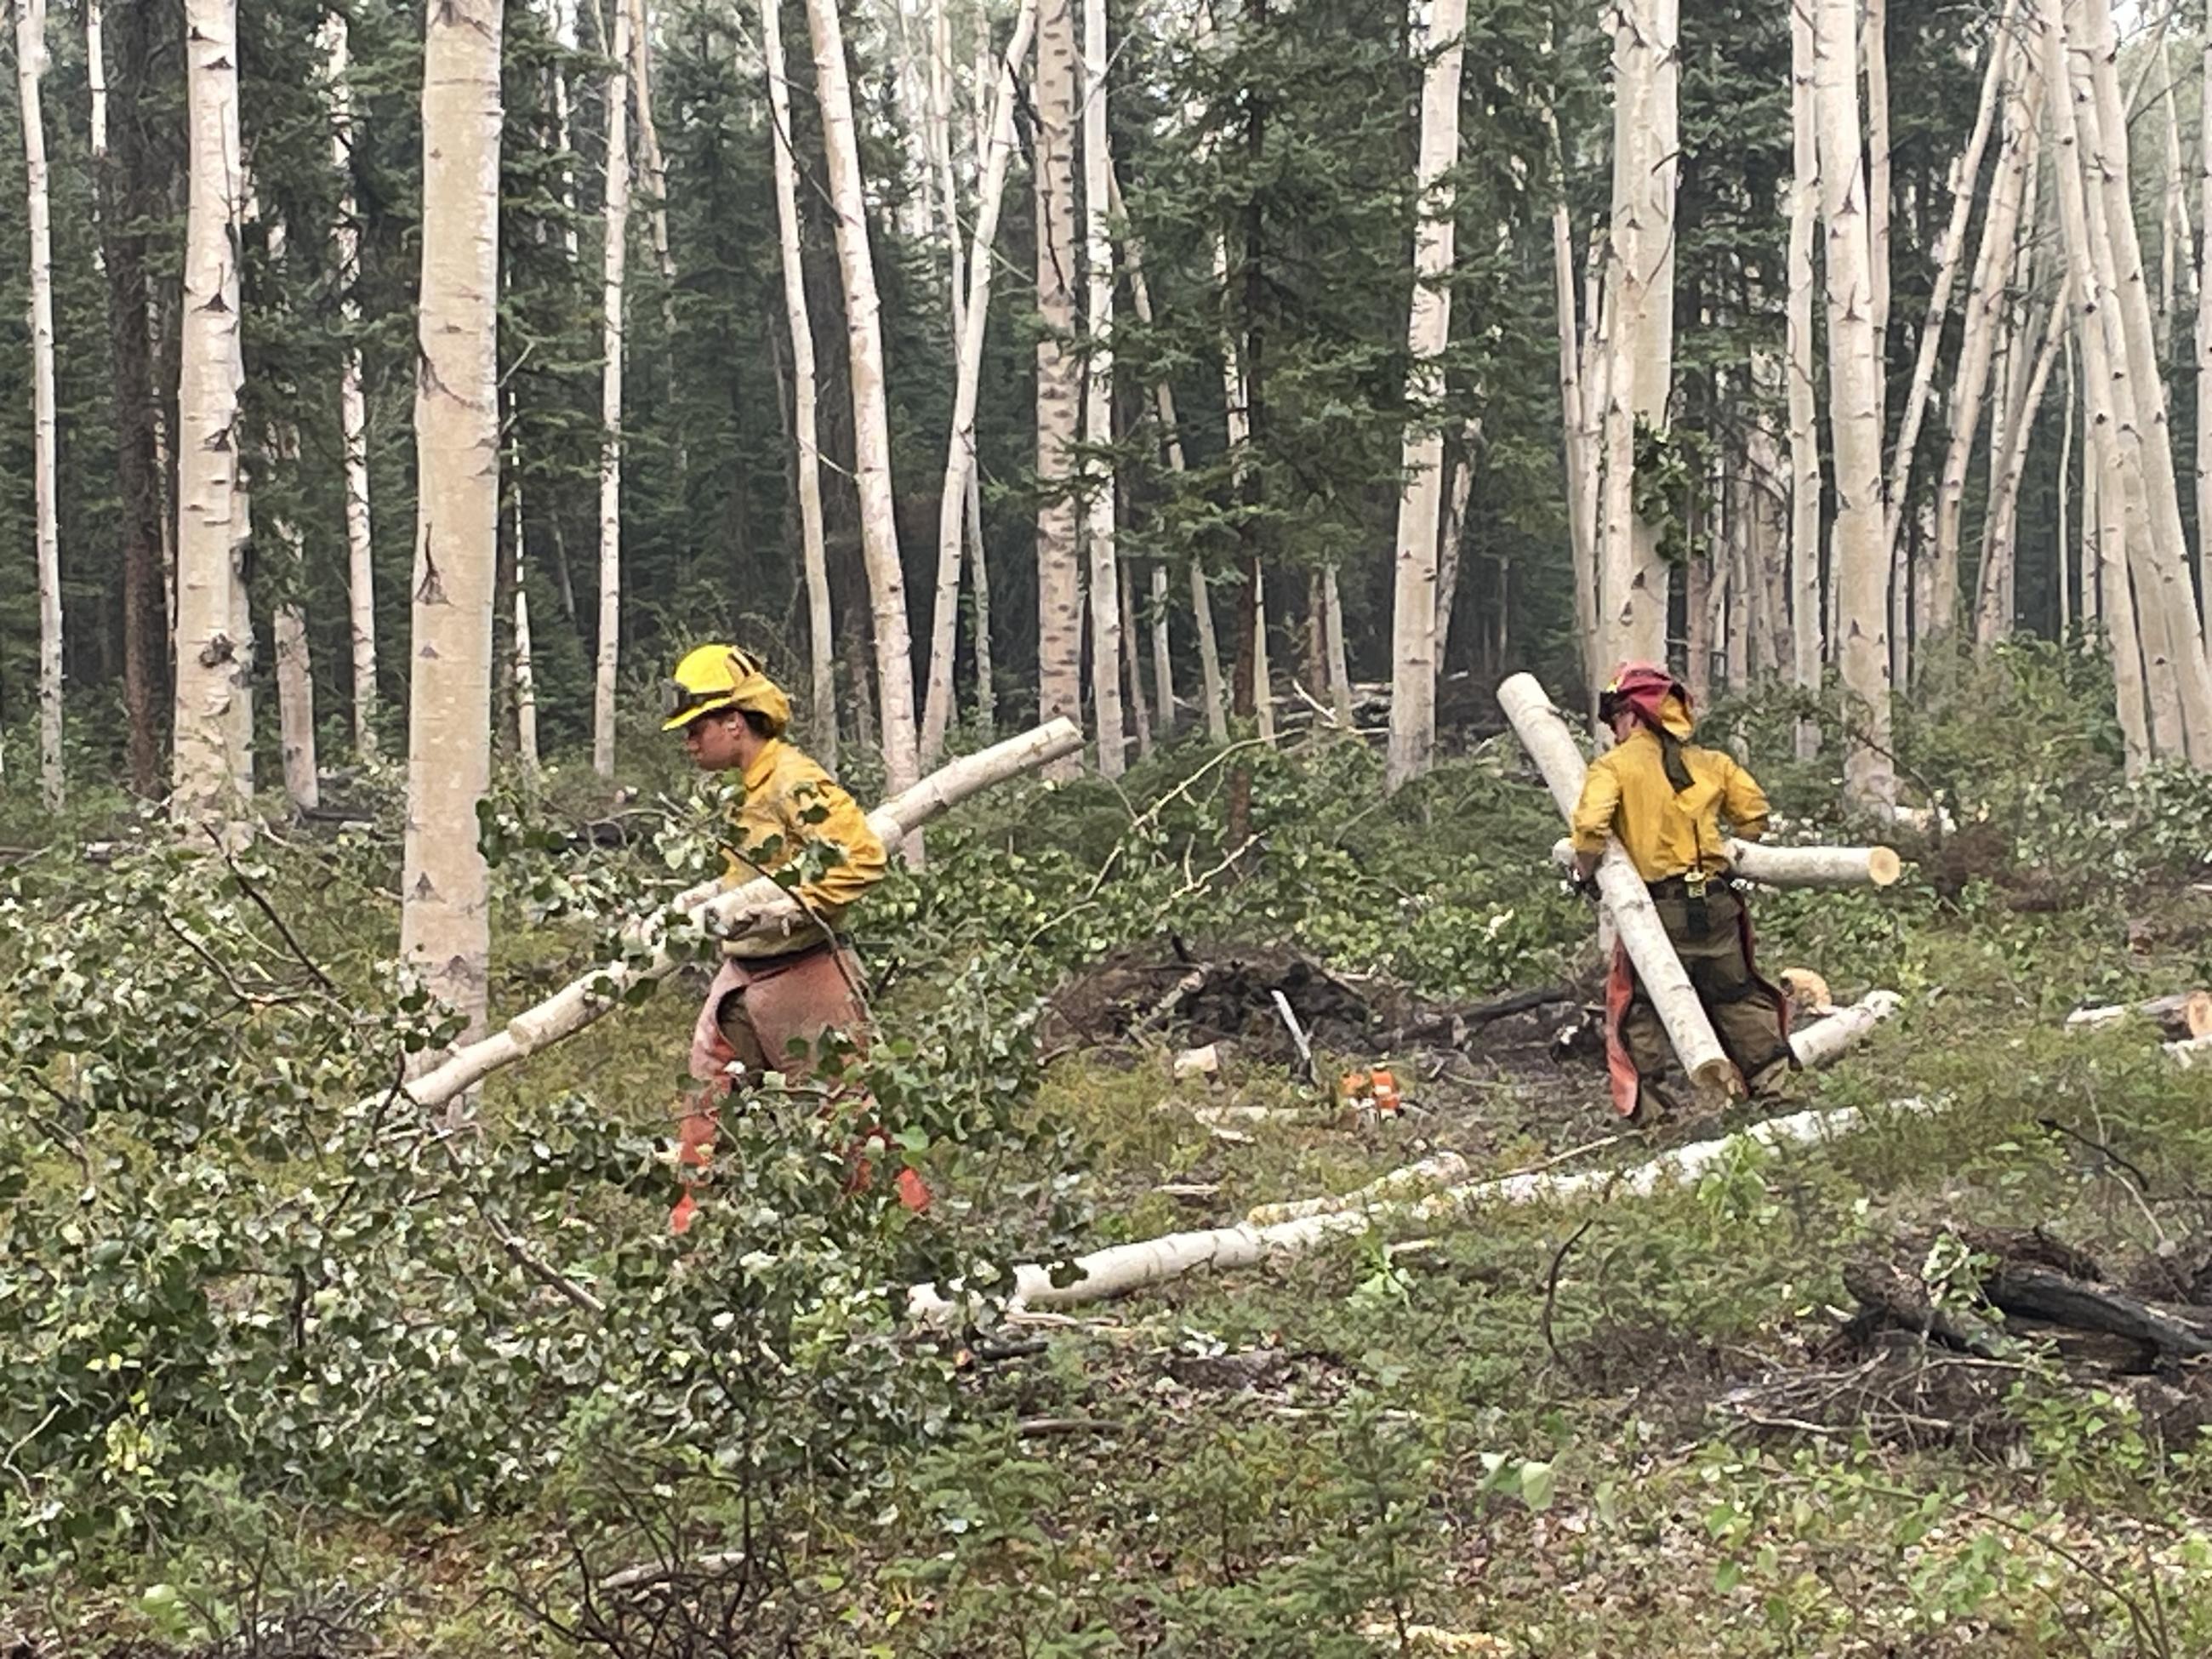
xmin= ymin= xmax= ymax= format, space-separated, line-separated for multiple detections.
xmin=1814 ymin=0 xmax=1898 ymax=807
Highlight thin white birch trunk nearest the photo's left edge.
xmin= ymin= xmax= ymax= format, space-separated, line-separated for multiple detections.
xmin=15 ymin=0 xmax=60 ymax=812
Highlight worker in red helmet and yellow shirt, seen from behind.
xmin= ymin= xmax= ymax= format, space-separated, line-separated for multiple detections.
xmin=1573 ymin=664 xmax=1796 ymax=1120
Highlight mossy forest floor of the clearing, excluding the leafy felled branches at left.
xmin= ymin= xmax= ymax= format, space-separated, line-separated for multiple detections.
xmin=13 ymin=658 xmax=2212 ymax=1659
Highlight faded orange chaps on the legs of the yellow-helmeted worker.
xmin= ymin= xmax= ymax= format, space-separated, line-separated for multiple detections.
xmin=668 ymin=944 xmax=929 ymax=1232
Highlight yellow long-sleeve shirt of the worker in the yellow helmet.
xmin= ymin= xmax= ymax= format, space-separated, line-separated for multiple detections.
xmin=723 ymin=738 xmax=885 ymax=955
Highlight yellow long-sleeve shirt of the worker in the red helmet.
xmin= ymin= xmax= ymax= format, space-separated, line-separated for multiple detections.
xmin=1573 ymin=727 xmax=1767 ymax=882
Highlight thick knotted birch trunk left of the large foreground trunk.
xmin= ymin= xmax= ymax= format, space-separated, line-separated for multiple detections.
xmin=170 ymin=0 xmax=248 ymax=845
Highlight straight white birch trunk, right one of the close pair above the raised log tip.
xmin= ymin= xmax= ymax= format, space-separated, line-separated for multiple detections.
xmin=1084 ymin=0 xmax=1123 ymax=778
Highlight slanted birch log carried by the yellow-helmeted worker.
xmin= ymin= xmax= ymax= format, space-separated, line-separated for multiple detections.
xmin=407 ymin=719 xmax=1084 ymax=1109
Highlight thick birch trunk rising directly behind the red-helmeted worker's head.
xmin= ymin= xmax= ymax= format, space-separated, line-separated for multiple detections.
xmin=1599 ymin=0 xmax=1681 ymax=664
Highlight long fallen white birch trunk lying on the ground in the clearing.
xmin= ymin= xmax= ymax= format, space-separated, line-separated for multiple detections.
xmin=907 ymin=1097 xmax=1933 ymax=1323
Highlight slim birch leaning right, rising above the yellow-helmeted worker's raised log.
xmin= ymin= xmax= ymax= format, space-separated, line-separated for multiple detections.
xmin=915 ymin=0 xmax=1037 ymax=766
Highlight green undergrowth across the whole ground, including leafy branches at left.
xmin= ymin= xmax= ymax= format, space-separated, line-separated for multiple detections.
xmin=13 ymin=650 xmax=2212 ymax=1659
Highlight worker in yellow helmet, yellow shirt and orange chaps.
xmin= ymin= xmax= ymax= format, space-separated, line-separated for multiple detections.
xmin=661 ymin=644 xmax=929 ymax=1232
